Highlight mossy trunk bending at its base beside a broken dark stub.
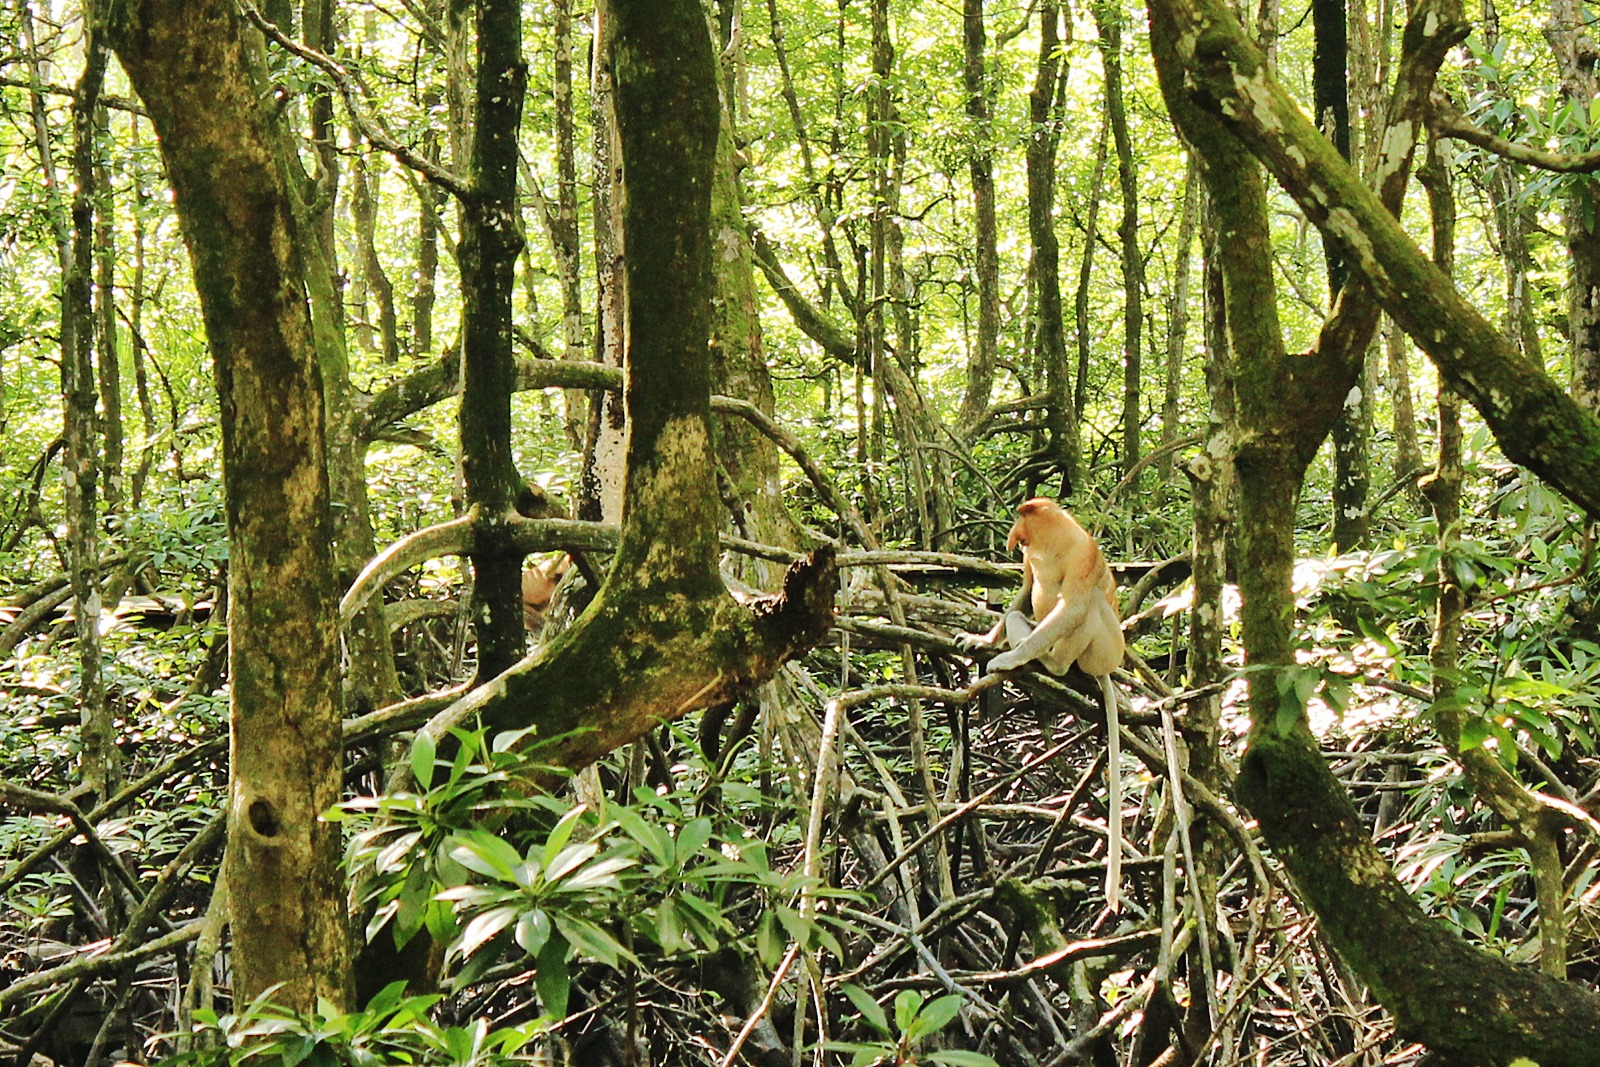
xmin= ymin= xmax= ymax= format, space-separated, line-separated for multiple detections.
xmin=412 ymin=0 xmax=835 ymax=768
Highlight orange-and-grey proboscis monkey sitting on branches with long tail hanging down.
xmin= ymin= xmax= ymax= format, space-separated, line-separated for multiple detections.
xmin=960 ymin=496 xmax=1125 ymax=910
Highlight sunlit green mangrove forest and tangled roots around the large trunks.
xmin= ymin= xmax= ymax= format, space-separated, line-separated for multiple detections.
xmin=0 ymin=0 xmax=1600 ymax=1065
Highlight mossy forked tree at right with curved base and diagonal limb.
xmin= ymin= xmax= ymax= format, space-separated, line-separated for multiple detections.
xmin=1150 ymin=0 xmax=1600 ymax=1067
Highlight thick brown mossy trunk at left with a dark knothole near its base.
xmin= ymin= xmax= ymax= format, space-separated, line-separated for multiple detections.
xmin=110 ymin=0 xmax=350 ymax=1008
